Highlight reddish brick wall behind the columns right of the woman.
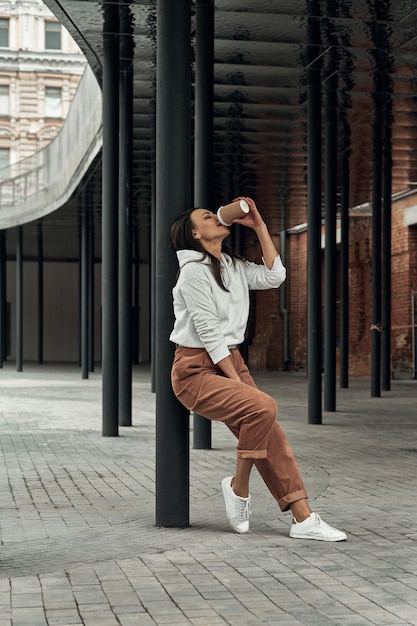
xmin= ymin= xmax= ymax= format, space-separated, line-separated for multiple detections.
xmin=247 ymin=194 xmax=417 ymax=378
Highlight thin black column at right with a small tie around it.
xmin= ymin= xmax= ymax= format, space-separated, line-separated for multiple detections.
xmin=371 ymin=97 xmax=383 ymax=397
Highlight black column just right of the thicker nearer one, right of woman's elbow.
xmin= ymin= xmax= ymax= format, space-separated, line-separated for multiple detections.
xmin=324 ymin=48 xmax=337 ymax=411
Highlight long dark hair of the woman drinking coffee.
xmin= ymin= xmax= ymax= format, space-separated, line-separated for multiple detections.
xmin=171 ymin=208 xmax=240 ymax=291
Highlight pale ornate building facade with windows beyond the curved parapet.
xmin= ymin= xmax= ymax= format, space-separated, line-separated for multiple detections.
xmin=0 ymin=0 xmax=86 ymax=173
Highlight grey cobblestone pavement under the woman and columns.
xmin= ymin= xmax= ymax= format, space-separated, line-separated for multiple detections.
xmin=0 ymin=364 xmax=417 ymax=626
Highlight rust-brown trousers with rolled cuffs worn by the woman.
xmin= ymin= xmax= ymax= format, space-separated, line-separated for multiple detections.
xmin=171 ymin=346 xmax=307 ymax=511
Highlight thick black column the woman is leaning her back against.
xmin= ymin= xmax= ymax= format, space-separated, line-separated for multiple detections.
xmin=155 ymin=0 xmax=191 ymax=527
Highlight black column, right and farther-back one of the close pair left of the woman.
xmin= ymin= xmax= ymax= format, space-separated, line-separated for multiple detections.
xmin=119 ymin=7 xmax=133 ymax=426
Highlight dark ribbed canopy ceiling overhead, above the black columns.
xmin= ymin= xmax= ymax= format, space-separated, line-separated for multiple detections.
xmin=11 ymin=0 xmax=417 ymax=254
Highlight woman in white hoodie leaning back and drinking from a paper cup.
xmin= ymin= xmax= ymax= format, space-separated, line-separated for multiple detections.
xmin=170 ymin=197 xmax=346 ymax=541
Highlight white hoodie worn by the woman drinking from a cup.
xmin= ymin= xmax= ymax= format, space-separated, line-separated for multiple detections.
xmin=170 ymin=250 xmax=286 ymax=363
